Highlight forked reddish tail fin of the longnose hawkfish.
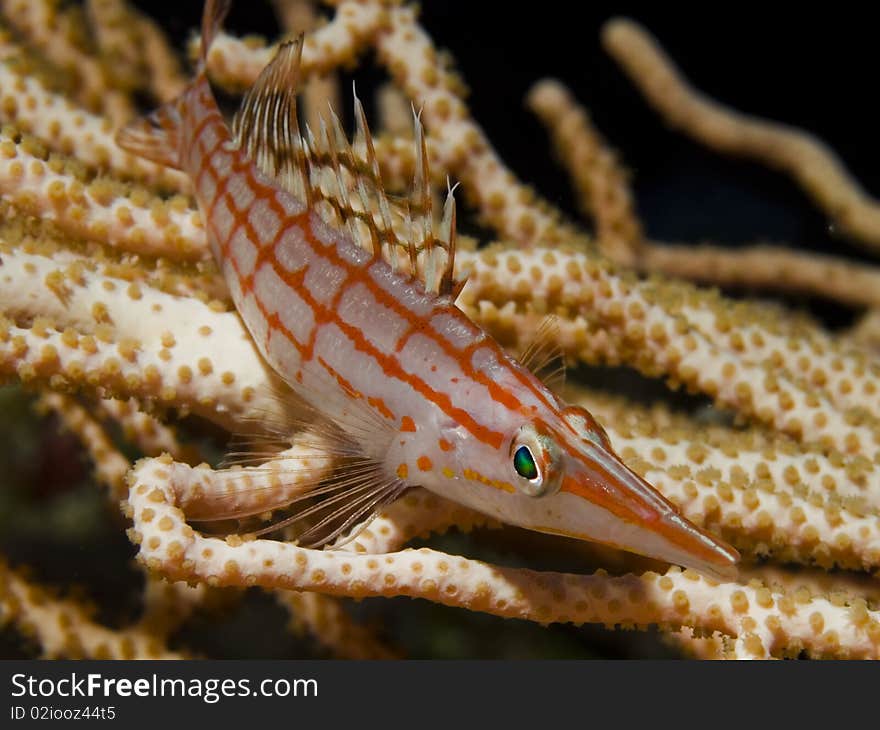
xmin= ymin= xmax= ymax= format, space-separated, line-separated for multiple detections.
xmin=116 ymin=0 xmax=231 ymax=169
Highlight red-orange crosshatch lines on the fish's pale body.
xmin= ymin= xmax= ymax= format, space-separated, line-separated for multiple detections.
xmin=175 ymin=59 xmax=732 ymax=557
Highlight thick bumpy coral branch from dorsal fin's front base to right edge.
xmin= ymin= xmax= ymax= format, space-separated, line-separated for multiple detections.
xmin=462 ymin=250 xmax=877 ymax=458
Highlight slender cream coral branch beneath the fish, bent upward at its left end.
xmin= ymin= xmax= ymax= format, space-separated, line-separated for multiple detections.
xmin=127 ymin=459 xmax=880 ymax=657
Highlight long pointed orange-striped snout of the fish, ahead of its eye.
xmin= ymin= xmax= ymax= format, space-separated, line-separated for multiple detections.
xmin=535 ymin=443 xmax=740 ymax=582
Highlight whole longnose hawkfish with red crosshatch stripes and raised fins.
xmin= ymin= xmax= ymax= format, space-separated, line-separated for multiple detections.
xmin=117 ymin=0 xmax=739 ymax=579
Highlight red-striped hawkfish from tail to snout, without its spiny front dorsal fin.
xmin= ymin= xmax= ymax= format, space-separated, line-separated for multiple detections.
xmin=119 ymin=0 xmax=738 ymax=576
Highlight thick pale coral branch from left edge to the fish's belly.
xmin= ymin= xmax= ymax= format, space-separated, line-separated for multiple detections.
xmin=0 ymin=250 xmax=278 ymax=427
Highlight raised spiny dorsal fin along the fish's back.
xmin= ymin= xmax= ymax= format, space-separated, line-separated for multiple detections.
xmin=232 ymin=37 xmax=463 ymax=297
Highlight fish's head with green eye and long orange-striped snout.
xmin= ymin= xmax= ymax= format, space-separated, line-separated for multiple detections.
xmin=470 ymin=405 xmax=739 ymax=580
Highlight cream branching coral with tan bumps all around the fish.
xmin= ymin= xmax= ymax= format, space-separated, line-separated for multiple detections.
xmin=0 ymin=0 xmax=880 ymax=658
